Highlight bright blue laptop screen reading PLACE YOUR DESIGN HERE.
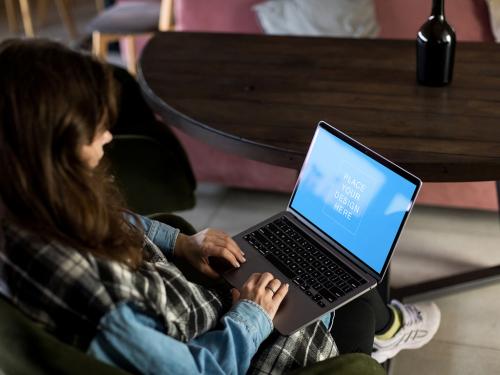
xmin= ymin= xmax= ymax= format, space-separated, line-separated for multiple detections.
xmin=290 ymin=127 xmax=417 ymax=273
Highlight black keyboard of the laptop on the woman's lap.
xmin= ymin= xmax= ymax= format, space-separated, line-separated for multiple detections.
xmin=243 ymin=217 xmax=366 ymax=307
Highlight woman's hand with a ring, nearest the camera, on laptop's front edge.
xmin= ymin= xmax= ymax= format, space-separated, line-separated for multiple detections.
xmin=232 ymin=272 xmax=289 ymax=319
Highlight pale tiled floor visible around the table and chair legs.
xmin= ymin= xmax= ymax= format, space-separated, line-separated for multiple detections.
xmin=0 ymin=0 xmax=500 ymax=375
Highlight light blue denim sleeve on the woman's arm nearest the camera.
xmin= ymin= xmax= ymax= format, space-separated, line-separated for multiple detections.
xmin=88 ymin=301 xmax=273 ymax=375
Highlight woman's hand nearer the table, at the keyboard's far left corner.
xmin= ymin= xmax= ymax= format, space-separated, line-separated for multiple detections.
xmin=174 ymin=228 xmax=246 ymax=278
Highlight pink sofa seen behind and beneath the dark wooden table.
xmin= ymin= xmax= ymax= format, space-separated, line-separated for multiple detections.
xmin=131 ymin=0 xmax=498 ymax=210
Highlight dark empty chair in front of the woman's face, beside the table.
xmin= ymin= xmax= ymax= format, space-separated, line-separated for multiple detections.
xmin=106 ymin=67 xmax=196 ymax=214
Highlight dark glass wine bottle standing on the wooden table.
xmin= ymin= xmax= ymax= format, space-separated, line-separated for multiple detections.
xmin=417 ymin=0 xmax=456 ymax=86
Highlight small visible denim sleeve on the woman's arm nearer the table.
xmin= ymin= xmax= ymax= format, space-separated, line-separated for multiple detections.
xmin=127 ymin=214 xmax=180 ymax=258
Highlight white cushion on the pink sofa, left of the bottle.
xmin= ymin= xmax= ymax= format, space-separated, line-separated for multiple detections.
xmin=253 ymin=0 xmax=379 ymax=38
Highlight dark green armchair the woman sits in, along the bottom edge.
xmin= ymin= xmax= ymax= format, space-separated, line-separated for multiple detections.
xmin=0 ymin=297 xmax=385 ymax=375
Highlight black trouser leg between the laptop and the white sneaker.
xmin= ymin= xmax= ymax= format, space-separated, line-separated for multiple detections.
xmin=331 ymin=280 xmax=394 ymax=355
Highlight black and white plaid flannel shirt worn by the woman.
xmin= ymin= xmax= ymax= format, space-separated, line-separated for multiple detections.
xmin=0 ymin=223 xmax=338 ymax=374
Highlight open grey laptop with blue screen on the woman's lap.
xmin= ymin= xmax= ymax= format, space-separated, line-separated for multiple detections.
xmin=223 ymin=121 xmax=422 ymax=335
